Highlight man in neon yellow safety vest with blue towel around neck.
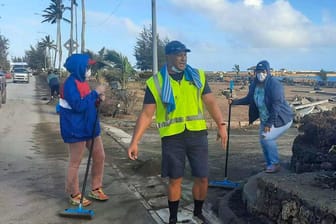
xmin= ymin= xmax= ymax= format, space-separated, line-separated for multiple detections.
xmin=128 ymin=41 xmax=227 ymax=224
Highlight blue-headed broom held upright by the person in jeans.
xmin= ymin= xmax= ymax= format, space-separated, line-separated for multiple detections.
xmin=208 ymin=80 xmax=239 ymax=189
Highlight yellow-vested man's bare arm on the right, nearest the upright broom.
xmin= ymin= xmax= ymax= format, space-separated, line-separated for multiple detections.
xmin=202 ymin=93 xmax=227 ymax=149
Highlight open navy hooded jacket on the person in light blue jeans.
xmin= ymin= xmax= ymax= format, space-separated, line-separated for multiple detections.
xmin=232 ymin=60 xmax=293 ymax=127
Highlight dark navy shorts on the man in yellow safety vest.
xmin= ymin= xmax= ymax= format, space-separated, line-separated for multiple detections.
xmin=161 ymin=132 xmax=209 ymax=179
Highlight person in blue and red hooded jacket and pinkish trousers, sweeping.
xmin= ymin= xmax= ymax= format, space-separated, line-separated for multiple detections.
xmin=59 ymin=54 xmax=108 ymax=206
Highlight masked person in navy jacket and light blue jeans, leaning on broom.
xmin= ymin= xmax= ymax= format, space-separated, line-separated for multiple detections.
xmin=229 ymin=60 xmax=293 ymax=173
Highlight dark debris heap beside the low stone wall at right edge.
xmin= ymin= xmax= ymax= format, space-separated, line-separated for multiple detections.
xmin=291 ymin=108 xmax=336 ymax=173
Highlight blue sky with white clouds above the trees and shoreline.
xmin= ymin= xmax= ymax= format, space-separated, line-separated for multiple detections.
xmin=0 ymin=0 xmax=336 ymax=71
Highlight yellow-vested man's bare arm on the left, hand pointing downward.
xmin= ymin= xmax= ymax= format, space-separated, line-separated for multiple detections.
xmin=127 ymin=104 xmax=156 ymax=160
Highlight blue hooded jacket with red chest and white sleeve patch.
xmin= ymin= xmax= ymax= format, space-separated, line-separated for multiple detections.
xmin=60 ymin=54 xmax=100 ymax=143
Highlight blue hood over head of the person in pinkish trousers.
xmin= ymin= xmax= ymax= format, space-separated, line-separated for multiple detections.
xmin=64 ymin=54 xmax=93 ymax=82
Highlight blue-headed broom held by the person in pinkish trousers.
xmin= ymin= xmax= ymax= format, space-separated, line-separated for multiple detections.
xmin=59 ymin=99 xmax=100 ymax=219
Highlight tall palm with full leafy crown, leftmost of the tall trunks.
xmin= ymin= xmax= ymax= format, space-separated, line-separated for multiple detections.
xmin=42 ymin=0 xmax=70 ymax=71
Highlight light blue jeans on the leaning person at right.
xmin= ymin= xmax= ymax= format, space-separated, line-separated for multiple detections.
xmin=259 ymin=121 xmax=293 ymax=166
